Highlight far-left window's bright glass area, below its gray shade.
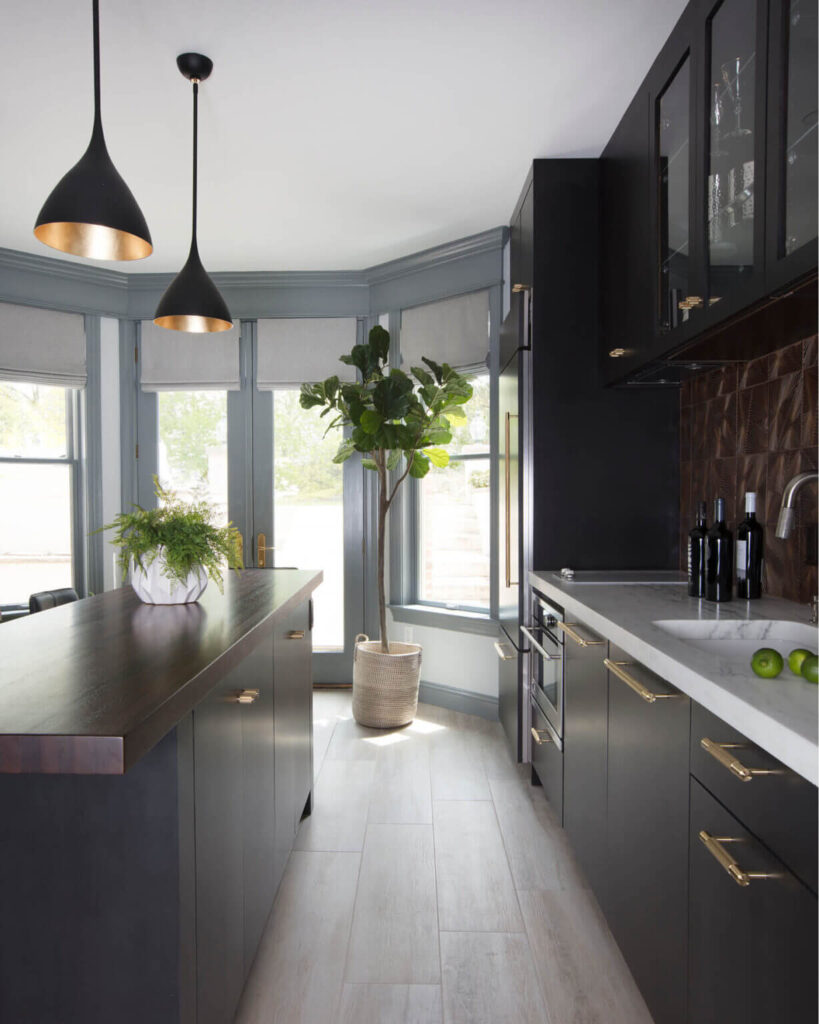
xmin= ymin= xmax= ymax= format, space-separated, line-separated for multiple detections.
xmin=0 ymin=381 xmax=81 ymax=605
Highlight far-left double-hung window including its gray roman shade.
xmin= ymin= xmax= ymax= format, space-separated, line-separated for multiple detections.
xmin=0 ymin=303 xmax=87 ymax=609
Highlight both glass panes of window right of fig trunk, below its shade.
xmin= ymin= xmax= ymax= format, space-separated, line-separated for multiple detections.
xmin=416 ymin=374 xmax=491 ymax=611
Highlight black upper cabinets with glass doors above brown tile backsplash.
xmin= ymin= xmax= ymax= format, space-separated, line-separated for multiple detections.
xmin=601 ymin=0 xmax=817 ymax=383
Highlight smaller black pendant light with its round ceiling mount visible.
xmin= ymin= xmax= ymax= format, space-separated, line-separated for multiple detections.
xmin=154 ymin=53 xmax=233 ymax=334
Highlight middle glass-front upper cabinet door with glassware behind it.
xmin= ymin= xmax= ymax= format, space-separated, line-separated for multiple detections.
xmin=703 ymin=0 xmax=765 ymax=315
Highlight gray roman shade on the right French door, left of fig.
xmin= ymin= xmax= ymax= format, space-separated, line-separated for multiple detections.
xmin=256 ymin=316 xmax=356 ymax=391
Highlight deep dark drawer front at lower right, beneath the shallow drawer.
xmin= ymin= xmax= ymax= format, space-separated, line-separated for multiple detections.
xmin=689 ymin=778 xmax=817 ymax=1024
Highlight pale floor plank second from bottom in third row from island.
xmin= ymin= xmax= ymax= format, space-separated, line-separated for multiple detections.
xmin=433 ymin=800 xmax=523 ymax=932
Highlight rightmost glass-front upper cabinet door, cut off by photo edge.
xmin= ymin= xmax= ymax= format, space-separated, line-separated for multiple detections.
xmin=767 ymin=0 xmax=819 ymax=286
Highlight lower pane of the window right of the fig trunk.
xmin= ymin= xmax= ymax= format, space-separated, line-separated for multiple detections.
xmin=419 ymin=459 xmax=489 ymax=609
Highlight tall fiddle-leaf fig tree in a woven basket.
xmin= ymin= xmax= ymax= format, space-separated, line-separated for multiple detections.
xmin=300 ymin=327 xmax=472 ymax=728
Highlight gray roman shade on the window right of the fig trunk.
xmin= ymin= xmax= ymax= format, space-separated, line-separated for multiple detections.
xmin=400 ymin=292 xmax=489 ymax=372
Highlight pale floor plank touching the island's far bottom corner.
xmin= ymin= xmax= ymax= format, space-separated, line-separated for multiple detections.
xmin=294 ymin=761 xmax=376 ymax=851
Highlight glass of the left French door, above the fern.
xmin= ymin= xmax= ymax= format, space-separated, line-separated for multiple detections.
xmin=158 ymin=391 xmax=227 ymax=524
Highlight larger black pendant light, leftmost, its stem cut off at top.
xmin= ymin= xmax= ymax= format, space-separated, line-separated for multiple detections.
xmin=34 ymin=0 xmax=154 ymax=260
